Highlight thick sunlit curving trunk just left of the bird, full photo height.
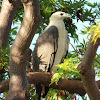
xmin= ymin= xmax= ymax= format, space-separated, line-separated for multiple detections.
xmin=6 ymin=0 xmax=41 ymax=100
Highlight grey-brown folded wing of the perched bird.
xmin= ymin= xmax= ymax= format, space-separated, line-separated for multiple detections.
xmin=33 ymin=26 xmax=59 ymax=72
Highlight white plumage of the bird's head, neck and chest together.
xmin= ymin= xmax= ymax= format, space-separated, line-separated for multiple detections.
xmin=47 ymin=11 xmax=70 ymax=72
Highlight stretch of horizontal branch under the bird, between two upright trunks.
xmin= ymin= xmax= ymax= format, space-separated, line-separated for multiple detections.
xmin=27 ymin=72 xmax=85 ymax=96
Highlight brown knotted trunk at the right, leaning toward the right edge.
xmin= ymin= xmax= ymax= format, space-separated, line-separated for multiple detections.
xmin=78 ymin=34 xmax=100 ymax=100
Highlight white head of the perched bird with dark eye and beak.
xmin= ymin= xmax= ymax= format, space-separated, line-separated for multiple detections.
xmin=50 ymin=11 xmax=70 ymax=21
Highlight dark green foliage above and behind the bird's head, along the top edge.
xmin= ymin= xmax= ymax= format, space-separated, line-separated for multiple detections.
xmin=40 ymin=0 xmax=100 ymax=40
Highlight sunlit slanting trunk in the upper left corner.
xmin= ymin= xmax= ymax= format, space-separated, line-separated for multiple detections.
xmin=0 ymin=0 xmax=20 ymax=48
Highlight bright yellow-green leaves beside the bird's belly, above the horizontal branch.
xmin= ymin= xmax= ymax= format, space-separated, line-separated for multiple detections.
xmin=51 ymin=56 xmax=80 ymax=84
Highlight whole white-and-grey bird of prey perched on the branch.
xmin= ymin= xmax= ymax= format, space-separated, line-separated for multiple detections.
xmin=32 ymin=11 xmax=70 ymax=100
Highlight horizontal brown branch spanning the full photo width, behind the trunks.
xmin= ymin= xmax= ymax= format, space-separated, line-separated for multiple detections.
xmin=0 ymin=72 xmax=100 ymax=96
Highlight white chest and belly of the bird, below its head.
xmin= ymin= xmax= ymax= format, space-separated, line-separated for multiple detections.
xmin=47 ymin=22 xmax=68 ymax=72
